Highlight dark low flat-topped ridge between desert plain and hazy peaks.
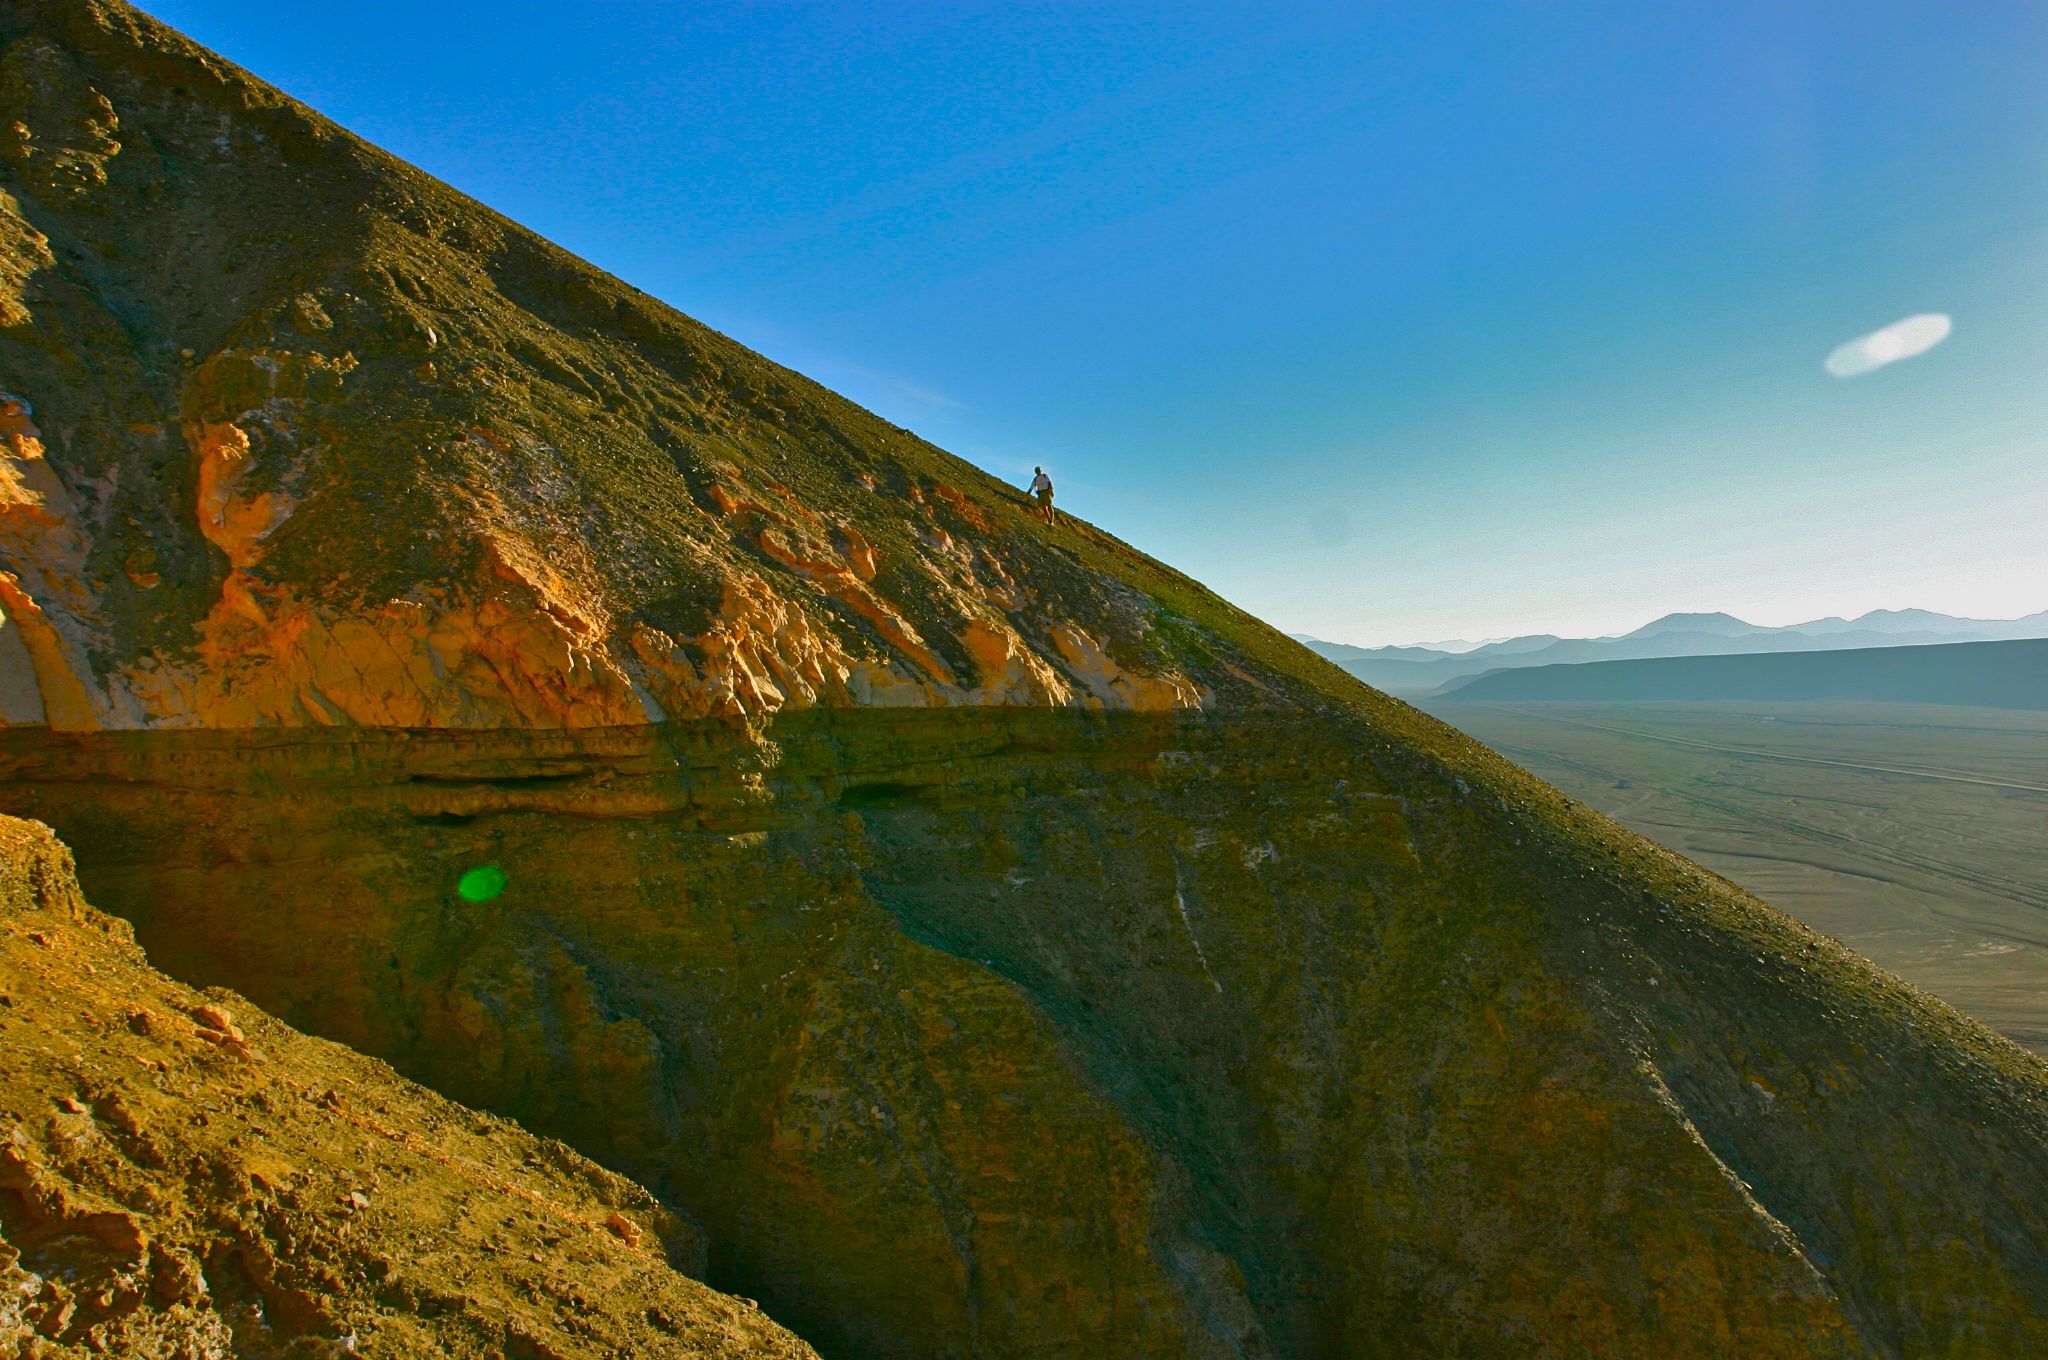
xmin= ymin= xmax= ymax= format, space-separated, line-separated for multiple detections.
xmin=1438 ymin=639 xmax=2048 ymax=711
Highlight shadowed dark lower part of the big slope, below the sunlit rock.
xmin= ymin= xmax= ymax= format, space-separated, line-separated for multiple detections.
xmin=16 ymin=709 xmax=2048 ymax=1356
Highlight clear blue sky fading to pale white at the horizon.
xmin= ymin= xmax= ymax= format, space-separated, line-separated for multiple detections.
xmin=145 ymin=0 xmax=2048 ymax=643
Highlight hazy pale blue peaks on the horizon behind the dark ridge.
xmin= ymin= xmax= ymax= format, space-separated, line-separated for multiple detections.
xmin=1294 ymin=608 xmax=2048 ymax=696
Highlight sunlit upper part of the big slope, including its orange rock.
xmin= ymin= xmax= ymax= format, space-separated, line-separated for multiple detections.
xmin=0 ymin=0 xmax=1233 ymax=729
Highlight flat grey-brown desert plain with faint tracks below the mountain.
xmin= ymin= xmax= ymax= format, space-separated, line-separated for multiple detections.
xmin=1440 ymin=703 xmax=2048 ymax=1053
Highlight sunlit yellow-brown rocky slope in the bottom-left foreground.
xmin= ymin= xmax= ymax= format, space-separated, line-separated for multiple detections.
xmin=0 ymin=817 xmax=813 ymax=1360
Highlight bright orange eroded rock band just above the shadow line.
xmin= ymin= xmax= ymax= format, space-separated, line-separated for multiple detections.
xmin=0 ymin=419 xmax=1204 ymax=731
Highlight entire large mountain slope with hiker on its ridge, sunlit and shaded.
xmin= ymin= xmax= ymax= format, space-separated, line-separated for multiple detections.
xmin=0 ymin=0 xmax=2048 ymax=1356
